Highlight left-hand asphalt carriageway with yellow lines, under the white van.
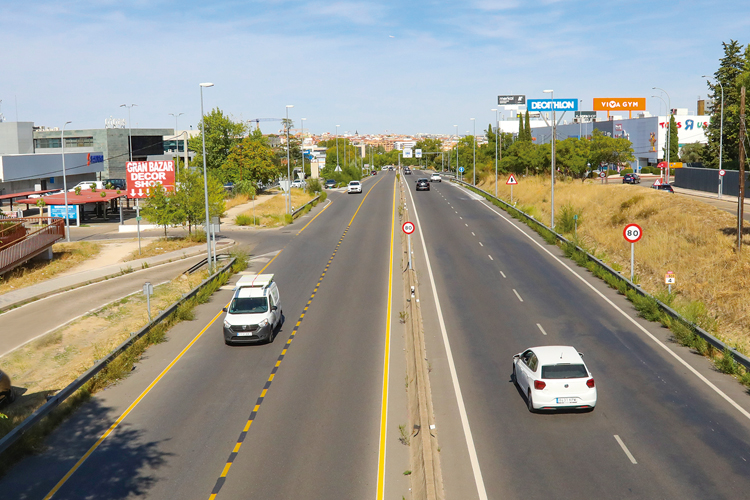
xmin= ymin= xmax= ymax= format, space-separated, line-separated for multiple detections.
xmin=0 ymin=172 xmax=408 ymax=498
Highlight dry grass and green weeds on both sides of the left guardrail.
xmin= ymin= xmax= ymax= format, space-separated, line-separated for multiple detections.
xmin=0 ymin=254 xmax=247 ymax=476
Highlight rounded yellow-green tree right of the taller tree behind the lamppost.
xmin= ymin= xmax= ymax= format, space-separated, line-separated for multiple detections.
xmin=220 ymin=134 xmax=281 ymax=184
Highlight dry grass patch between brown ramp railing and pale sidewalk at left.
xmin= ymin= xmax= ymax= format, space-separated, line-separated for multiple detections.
xmin=0 ymin=241 xmax=101 ymax=294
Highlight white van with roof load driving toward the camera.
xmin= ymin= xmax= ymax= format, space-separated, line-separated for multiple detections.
xmin=224 ymin=274 xmax=283 ymax=345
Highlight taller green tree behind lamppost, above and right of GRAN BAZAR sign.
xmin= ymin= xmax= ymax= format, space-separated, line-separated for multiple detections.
xmin=188 ymin=108 xmax=247 ymax=172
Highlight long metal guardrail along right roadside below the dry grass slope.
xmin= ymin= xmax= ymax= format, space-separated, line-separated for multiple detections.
xmin=451 ymin=178 xmax=750 ymax=369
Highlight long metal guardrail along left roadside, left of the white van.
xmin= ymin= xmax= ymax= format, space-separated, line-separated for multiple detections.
xmin=0 ymin=257 xmax=237 ymax=454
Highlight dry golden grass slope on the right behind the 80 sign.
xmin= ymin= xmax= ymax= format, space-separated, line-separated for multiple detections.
xmin=480 ymin=176 xmax=750 ymax=352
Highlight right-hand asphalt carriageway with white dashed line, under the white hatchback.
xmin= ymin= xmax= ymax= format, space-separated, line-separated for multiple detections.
xmin=407 ymin=175 xmax=750 ymax=499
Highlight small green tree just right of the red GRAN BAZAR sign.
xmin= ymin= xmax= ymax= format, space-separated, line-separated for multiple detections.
xmin=172 ymin=168 xmax=225 ymax=234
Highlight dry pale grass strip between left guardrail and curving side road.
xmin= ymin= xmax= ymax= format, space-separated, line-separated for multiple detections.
xmin=0 ymin=274 xmax=205 ymax=418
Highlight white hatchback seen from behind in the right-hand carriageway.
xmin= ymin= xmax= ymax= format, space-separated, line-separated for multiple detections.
xmin=513 ymin=346 xmax=596 ymax=412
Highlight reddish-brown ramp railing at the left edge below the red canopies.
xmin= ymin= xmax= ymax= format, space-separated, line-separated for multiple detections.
xmin=0 ymin=217 xmax=65 ymax=274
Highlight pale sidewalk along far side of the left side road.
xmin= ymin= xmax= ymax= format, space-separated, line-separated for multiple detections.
xmin=0 ymin=239 xmax=235 ymax=313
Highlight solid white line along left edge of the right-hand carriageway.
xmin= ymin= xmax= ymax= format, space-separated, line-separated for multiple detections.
xmin=406 ymin=178 xmax=488 ymax=500
